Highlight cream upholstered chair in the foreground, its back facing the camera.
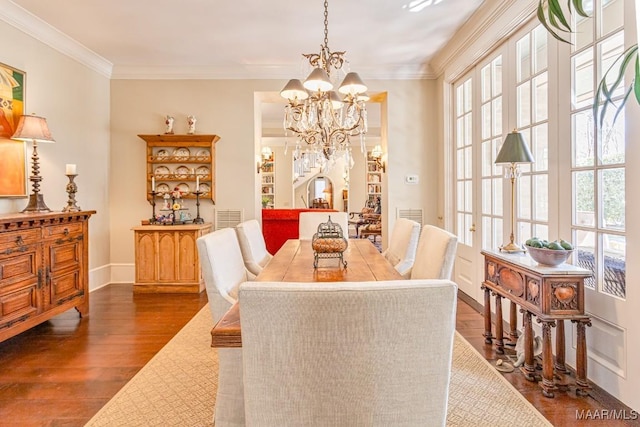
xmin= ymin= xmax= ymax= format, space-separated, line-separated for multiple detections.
xmin=239 ymin=280 xmax=457 ymax=427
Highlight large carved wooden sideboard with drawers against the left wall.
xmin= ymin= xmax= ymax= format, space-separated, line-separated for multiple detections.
xmin=0 ymin=211 xmax=96 ymax=342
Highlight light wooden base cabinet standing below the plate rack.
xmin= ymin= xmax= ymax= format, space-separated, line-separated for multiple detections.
xmin=133 ymin=223 xmax=211 ymax=293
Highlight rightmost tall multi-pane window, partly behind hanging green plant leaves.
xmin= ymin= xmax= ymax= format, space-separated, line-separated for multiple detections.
xmin=571 ymin=0 xmax=626 ymax=298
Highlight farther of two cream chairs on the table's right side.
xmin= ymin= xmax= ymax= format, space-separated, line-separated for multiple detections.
xmin=382 ymin=218 xmax=420 ymax=279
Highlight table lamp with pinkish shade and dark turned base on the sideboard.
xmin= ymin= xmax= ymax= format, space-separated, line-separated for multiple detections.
xmin=11 ymin=115 xmax=55 ymax=212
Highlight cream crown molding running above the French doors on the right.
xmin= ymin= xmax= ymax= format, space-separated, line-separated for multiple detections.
xmin=431 ymin=0 xmax=538 ymax=81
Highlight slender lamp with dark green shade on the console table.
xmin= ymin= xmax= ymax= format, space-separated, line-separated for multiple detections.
xmin=494 ymin=129 xmax=534 ymax=252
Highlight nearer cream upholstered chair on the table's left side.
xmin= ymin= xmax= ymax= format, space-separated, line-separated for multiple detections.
xmin=196 ymin=228 xmax=255 ymax=427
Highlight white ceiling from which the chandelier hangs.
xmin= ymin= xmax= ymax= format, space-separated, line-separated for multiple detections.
xmin=8 ymin=0 xmax=483 ymax=80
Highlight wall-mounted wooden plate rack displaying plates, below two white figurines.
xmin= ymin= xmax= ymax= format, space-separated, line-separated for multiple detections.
xmin=138 ymin=134 xmax=220 ymax=200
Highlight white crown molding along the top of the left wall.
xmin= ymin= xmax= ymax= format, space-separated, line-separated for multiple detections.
xmin=0 ymin=0 xmax=113 ymax=78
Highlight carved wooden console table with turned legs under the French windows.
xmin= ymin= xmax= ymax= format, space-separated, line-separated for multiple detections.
xmin=481 ymin=250 xmax=592 ymax=397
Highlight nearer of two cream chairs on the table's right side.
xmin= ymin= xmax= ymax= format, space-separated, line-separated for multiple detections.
xmin=411 ymin=225 xmax=458 ymax=279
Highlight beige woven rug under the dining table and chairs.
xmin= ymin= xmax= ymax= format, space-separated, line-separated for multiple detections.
xmin=86 ymin=306 xmax=551 ymax=427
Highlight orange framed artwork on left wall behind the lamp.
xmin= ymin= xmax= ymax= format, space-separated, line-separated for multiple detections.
xmin=0 ymin=63 xmax=27 ymax=197
